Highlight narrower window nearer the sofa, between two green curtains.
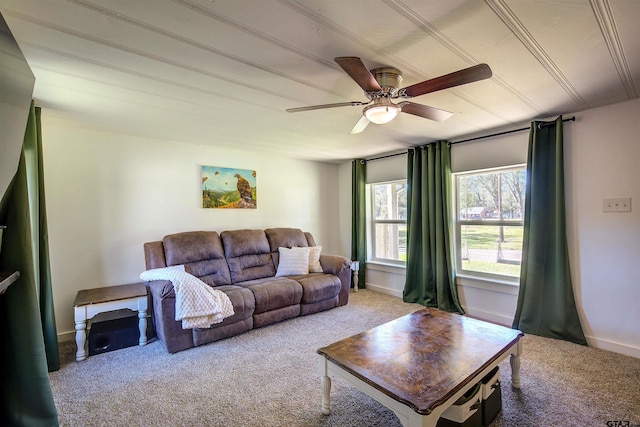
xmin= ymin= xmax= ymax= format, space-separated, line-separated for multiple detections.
xmin=370 ymin=180 xmax=407 ymax=263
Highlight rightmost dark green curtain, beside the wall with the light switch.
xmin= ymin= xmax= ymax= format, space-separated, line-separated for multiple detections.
xmin=513 ymin=117 xmax=587 ymax=345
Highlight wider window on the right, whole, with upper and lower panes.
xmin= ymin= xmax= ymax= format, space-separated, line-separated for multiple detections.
xmin=454 ymin=166 xmax=526 ymax=281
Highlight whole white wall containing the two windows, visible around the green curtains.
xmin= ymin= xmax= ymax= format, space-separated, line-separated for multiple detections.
xmin=341 ymin=99 xmax=640 ymax=357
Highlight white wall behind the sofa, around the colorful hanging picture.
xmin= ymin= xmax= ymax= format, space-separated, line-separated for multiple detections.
xmin=43 ymin=115 xmax=349 ymax=339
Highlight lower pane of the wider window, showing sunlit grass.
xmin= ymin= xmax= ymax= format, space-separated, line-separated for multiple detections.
xmin=460 ymin=225 xmax=523 ymax=277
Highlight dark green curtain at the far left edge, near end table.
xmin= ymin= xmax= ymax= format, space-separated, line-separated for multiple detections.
xmin=0 ymin=102 xmax=60 ymax=426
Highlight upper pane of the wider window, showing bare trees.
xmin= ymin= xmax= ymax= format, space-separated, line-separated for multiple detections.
xmin=458 ymin=169 xmax=525 ymax=221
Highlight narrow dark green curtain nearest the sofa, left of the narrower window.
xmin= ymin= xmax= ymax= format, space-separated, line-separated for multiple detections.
xmin=351 ymin=159 xmax=367 ymax=288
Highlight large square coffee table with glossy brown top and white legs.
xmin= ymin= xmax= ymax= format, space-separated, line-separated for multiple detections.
xmin=318 ymin=308 xmax=523 ymax=427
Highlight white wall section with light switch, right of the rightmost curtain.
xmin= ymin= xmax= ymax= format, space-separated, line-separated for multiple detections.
xmin=565 ymin=99 xmax=640 ymax=357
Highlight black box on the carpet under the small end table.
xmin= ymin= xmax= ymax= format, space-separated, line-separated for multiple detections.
xmin=88 ymin=316 xmax=140 ymax=356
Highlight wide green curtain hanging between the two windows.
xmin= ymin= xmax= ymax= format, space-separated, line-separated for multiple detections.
xmin=403 ymin=141 xmax=464 ymax=313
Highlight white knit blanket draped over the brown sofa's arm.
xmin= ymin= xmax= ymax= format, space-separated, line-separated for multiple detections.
xmin=140 ymin=265 xmax=234 ymax=329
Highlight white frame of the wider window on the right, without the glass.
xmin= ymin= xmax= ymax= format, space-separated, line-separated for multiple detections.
xmin=451 ymin=163 xmax=527 ymax=285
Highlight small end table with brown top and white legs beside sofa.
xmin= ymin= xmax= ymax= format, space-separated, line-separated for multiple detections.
xmin=73 ymin=283 xmax=148 ymax=362
